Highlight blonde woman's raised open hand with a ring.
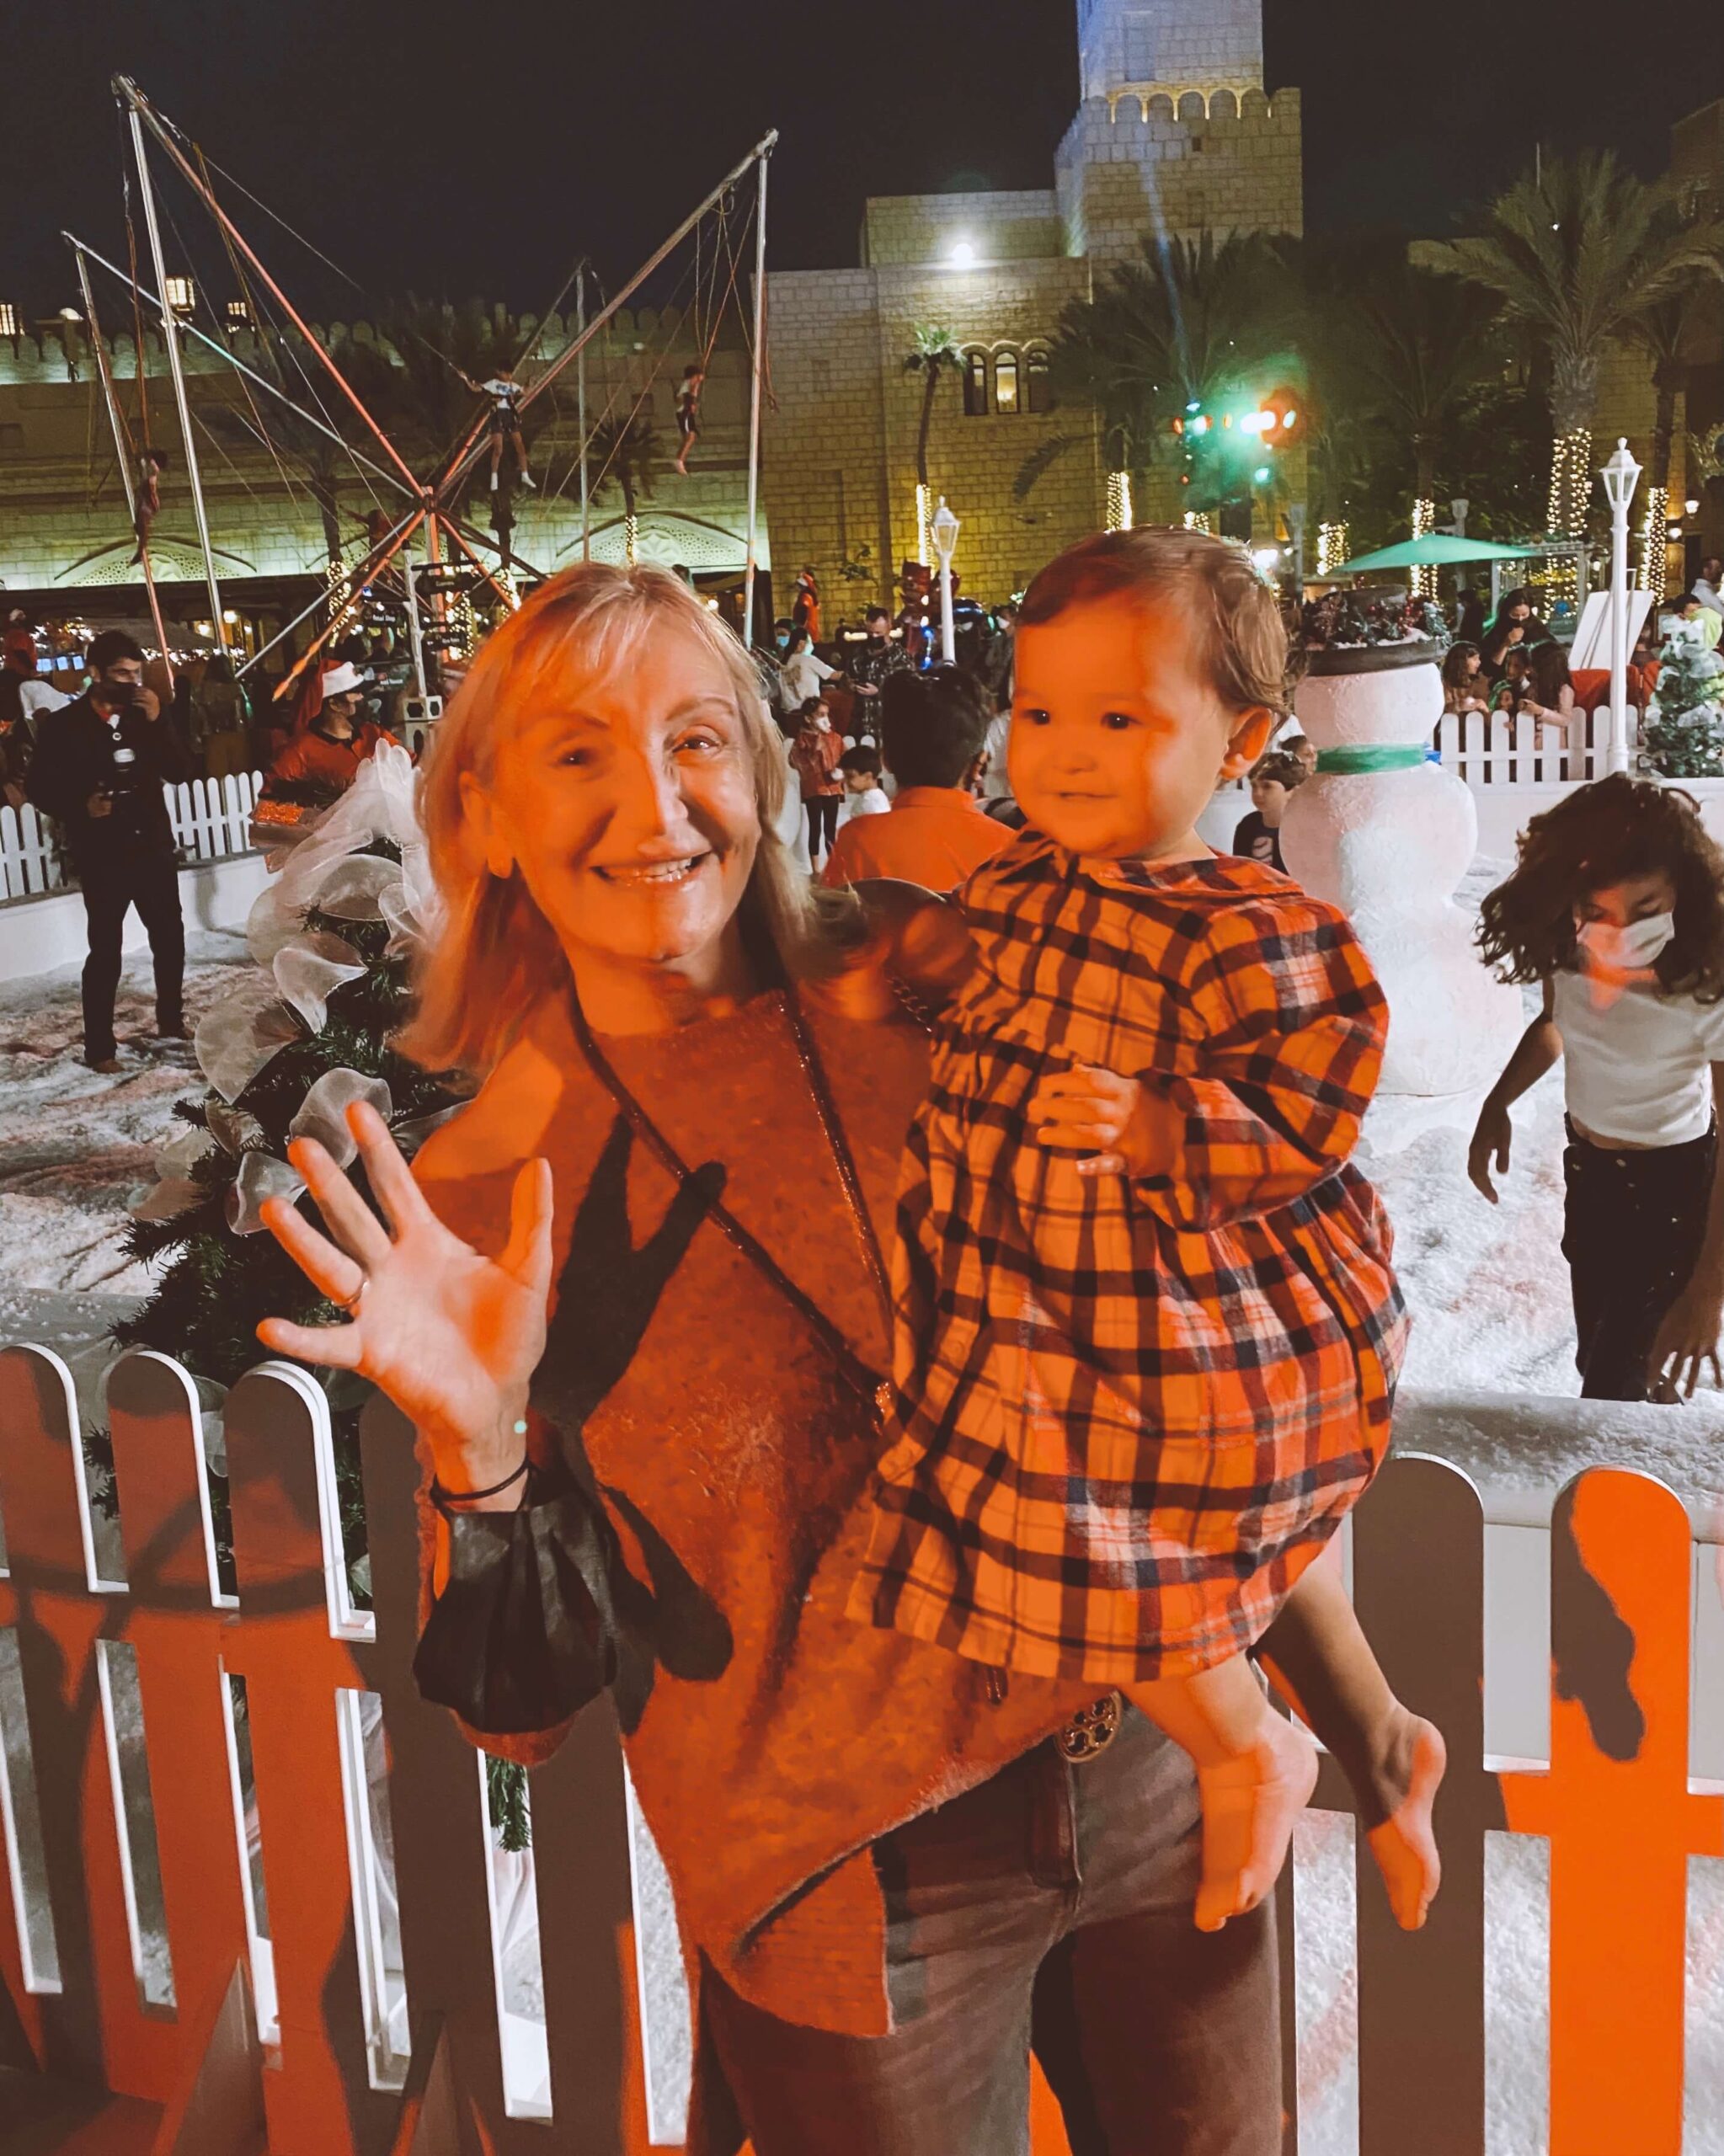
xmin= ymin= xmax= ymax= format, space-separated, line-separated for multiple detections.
xmin=256 ymin=1102 xmax=552 ymax=1490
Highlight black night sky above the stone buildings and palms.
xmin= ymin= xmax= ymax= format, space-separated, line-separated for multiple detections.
xmin=0 ymin=0 xmax=1724 ymax=315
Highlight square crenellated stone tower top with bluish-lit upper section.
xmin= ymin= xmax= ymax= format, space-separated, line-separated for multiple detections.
xmin=1056 ymin=0 xmax=1304 ymax=263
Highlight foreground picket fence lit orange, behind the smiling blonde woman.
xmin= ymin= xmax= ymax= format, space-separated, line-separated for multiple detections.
xmin=0 ymin=1348 xmax=1724 ymax=2156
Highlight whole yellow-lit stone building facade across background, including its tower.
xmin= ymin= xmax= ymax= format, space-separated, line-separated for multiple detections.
xmin=0 ymin=0 xmax=1301 ymax=638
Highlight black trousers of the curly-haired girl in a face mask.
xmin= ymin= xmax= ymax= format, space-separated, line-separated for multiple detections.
xmin=1562 ymin=1123 xmax=1717 ymax=1399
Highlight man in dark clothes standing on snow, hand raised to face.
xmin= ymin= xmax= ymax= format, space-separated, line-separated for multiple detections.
xmin=24 ymin=630 xmax=189 ymax=1071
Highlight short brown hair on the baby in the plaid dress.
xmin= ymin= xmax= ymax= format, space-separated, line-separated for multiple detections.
xmin=1019 ymin=524 xmax=1287 ymax=712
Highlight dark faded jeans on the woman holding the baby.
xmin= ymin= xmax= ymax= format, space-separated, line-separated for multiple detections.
xmin=702 ymin=1708 xmax=1280 ymax=2156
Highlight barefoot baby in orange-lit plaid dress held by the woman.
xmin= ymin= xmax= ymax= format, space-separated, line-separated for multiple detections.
xmin=851 ymin=531 xmax=1444 ymax=1929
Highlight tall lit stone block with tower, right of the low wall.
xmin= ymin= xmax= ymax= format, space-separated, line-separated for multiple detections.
xmin=765 ymin=0 xmax=1304 ymax=612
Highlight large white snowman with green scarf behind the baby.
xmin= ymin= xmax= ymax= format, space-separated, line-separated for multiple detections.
xmin=1280 ymin=640 xmax=1524 ymax=1097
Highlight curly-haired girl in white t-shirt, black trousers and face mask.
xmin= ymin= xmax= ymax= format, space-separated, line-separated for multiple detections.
xmin=1468 ymin=776 xmax=1724 ymax=1399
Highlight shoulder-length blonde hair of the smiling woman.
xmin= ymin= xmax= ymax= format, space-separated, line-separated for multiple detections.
xmin=397 ymin=563 xmax=860 ymax=1078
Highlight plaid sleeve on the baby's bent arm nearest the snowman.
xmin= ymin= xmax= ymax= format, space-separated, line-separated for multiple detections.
xmin=1140 ymin=897 xmax=1388 ymax=1231
